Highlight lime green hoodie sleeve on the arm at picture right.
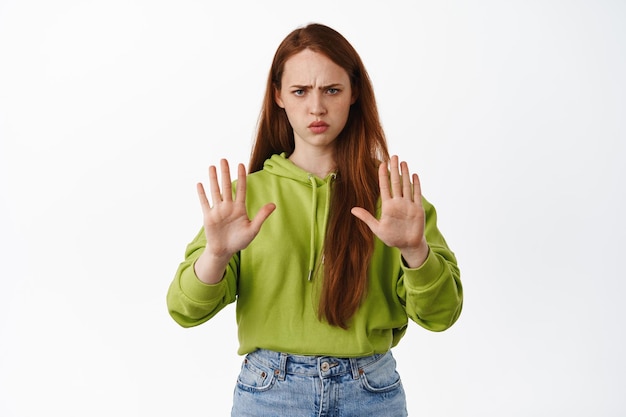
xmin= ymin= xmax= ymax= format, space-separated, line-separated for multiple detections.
xmin=397 ymin=199 xmax=463 ymax=331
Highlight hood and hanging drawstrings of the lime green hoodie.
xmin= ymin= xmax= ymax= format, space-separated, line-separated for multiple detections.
xmin=263 ymin=153 xmax=337 ymax=281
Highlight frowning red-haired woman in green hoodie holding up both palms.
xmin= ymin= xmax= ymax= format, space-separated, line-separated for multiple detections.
xmin=167 ymin=24 xmax=462 ymax=416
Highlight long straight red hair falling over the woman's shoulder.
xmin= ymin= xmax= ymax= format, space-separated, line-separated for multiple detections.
xmin=249 ymin=24 xmax=389 ymax=328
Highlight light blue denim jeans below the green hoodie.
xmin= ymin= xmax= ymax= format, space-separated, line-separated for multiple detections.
xmin=231 ymin=350 xmax=407 ymax=417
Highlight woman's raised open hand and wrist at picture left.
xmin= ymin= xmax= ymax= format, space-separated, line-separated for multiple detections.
xmin=194 ymin=159 xmax=276 ymax=284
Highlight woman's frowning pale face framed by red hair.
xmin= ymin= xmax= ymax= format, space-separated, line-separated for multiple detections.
xmin=275 ymin=49 xmax=354 ymax=151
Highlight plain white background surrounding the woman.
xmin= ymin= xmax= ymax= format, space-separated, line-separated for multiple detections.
xmin=0 ymin=0 xmax=626 ymax=417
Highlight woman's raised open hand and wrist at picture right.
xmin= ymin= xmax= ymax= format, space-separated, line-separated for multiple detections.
xmin=352 ymin=155 xmax=429 ymax=268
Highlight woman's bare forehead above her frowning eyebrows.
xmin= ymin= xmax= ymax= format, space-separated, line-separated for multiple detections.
xmin=282 ymin=49 xmax=350 ymax=85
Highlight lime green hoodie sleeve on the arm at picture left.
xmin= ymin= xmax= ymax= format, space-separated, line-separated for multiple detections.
xmin=167 ymin=229 xmax=239 ymax=327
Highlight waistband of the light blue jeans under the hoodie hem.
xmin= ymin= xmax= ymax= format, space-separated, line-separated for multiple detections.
xmin=246 ymin=349 xmax=391 ymax=380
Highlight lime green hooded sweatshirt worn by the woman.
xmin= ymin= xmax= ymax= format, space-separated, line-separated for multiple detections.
xmin=167 ymin=154 xmax=463 ymax=357
